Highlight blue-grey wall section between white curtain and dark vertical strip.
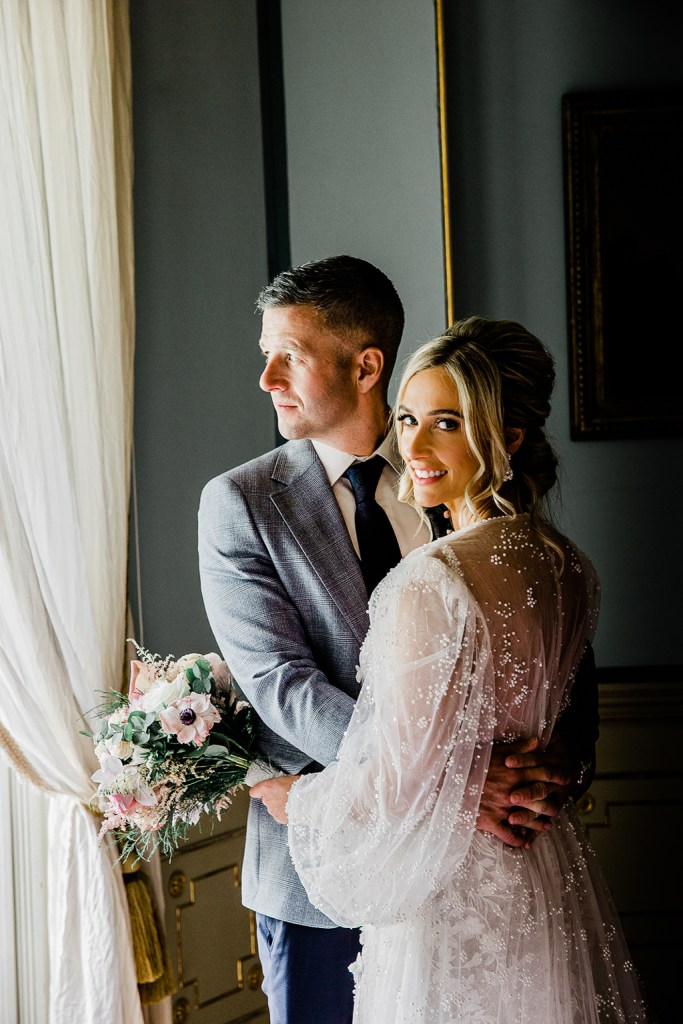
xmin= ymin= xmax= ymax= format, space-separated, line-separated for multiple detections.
xmin=130 ymin=0 xmax=275 ymax=654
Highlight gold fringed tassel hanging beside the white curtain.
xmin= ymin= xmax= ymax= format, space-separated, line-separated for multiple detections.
xmin=122 ymin=862 xmax=174 ymax=1004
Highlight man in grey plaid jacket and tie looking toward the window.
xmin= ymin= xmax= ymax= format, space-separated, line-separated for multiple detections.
xmin=199 ymin=249 xmax=597 ymax=1024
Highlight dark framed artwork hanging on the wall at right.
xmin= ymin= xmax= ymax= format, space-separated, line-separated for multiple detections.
xmin=562 ymin=92 xmax=683 ymax=440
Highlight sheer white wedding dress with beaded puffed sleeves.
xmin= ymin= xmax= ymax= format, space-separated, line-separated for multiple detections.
xmin=288 ymin=515 xmax=647 ymax=1024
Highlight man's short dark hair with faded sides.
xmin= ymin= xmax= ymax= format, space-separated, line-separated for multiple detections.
xmin=256 ymin=256 xmax=405 ymax=385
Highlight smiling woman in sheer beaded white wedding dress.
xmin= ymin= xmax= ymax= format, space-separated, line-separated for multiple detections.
xmin=250 ymin=317 xmax=648 ymax=1024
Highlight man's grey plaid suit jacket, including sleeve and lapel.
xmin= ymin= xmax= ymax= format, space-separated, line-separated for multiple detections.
xmin=199 ymin=440 xmax=378 ymax=927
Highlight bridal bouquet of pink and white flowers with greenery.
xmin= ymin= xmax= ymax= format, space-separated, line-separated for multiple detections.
xmin=87 ymin=641 xmax=256 ymax=860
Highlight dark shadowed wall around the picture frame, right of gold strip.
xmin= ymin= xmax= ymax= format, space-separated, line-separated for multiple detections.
xmin=443 ymin=0 xmax=683 ymax=675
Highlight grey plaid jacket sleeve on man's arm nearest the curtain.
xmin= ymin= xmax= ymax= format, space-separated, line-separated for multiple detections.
xmin=199 ymin=476 xmax=355 ymax=772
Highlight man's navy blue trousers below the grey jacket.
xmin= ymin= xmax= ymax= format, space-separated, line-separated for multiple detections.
xmin=256 ymin=913 xmax=360 ymax=1024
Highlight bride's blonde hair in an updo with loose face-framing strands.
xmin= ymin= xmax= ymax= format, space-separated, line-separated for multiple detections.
xmin=396 ymin=316 xmax=557 ymax=526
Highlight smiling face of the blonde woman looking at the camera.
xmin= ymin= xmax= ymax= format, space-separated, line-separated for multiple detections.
xmin=396 ymin=368 xmax=478 ymax=521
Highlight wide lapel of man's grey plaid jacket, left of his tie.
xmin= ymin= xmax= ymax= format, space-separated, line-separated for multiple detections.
xmin=270 ymin=441 xmax=369 ymax=643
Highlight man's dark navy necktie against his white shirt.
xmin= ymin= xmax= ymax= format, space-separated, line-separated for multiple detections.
xmin=344 ymin=455 xmax=400 ymax=597
